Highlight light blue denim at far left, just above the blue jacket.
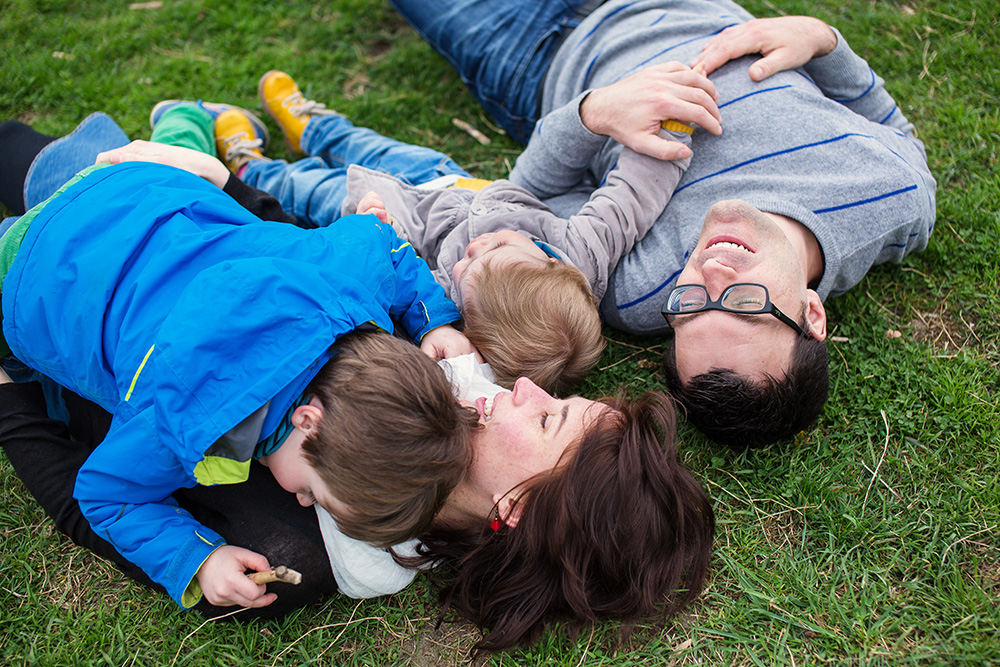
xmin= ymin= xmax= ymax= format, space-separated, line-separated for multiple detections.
xmin=24 ymin=113 xmax=129 ymax=209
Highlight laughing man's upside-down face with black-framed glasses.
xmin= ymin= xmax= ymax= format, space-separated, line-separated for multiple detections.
xmin=671 ymin=199 xmax=826 ymax=382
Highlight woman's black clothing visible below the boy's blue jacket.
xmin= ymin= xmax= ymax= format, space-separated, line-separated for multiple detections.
xmin=0 ymin=382 xmax=337 ymax=620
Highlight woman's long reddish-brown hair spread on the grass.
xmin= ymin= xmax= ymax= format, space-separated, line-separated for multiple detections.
xmin=410 ymin=392 xmax=715 ymax=651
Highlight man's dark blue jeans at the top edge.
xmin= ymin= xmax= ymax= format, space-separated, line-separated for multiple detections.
xmin=389 ymin=0 xmax=585 ymax=144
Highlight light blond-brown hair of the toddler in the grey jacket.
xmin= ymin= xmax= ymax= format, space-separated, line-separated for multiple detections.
xmin=463 ymin=261 xmax=604 ymax=393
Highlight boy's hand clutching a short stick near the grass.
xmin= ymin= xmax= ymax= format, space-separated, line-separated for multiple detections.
xmin=195 ymin=545 xmax=278 ymax=607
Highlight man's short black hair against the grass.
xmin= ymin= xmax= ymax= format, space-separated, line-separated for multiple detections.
xmin=663 ymin=333 xmax=830 ymax=447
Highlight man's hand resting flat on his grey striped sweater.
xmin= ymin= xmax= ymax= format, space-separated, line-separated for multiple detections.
xmin=691 ymin=16 xmax=837 ymax=81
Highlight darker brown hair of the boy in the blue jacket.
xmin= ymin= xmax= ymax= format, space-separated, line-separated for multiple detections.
xmin=302 ymin=333 xmax=479 ymax=547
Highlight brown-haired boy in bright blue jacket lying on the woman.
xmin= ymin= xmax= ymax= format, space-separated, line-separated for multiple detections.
xmin=0 ymin=117 xmax=475 ymax=607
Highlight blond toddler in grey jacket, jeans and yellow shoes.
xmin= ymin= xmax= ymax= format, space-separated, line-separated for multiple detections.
xmin=135 ymin=71 xmax=690 ymax=392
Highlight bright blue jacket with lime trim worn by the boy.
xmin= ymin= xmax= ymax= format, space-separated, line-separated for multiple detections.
xmin=2 ymin=162 xmax=459 ymax=606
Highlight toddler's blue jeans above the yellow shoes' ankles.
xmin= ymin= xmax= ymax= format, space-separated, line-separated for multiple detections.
xmin=241 ymin=116 xmax=469 ymax=227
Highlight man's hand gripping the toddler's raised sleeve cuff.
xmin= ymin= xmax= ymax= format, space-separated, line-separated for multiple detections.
xmin=580 ymin=62 xmax=722 ymax=160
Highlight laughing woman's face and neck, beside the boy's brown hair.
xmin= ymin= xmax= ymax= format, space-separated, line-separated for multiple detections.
xmin=448 ymin=378 xmax=610 ymax=524
